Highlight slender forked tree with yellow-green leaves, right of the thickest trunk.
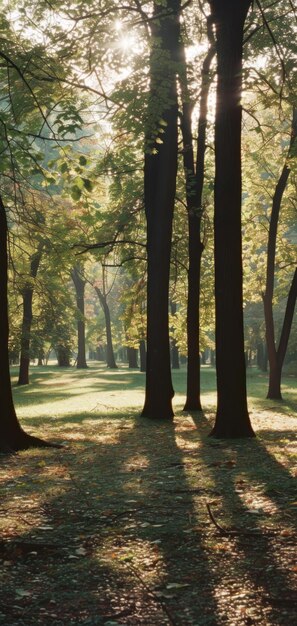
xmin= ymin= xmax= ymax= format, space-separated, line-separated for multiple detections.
xmin=245 ymin=0 xmax=297 ymax=400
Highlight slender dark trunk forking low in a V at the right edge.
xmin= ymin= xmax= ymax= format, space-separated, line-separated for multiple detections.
xmin=263 ymin=108 xmax=297 ymax=400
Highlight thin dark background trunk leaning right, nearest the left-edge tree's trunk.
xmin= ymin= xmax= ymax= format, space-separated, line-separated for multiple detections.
xmin=18 ymin=243 xmax=43 ymax=385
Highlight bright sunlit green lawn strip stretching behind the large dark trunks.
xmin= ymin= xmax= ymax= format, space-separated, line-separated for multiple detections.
xmin=12 ymin=363 xmax=297 ymax=419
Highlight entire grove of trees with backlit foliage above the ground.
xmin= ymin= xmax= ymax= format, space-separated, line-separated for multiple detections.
xmin=0 ymin=0 xmax=297 ymax=450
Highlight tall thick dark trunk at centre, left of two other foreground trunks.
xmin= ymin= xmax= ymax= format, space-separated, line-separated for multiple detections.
xmin=142 ymin=0 xmax=180 ymax=419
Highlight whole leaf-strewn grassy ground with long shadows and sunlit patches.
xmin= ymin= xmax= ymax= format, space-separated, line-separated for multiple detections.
xmin=0 ymin=364 xmax=297 ymax=626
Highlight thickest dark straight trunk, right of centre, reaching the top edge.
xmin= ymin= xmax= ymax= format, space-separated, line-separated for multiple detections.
xmin=210 ymin=0 xmax=254 ymax=438
